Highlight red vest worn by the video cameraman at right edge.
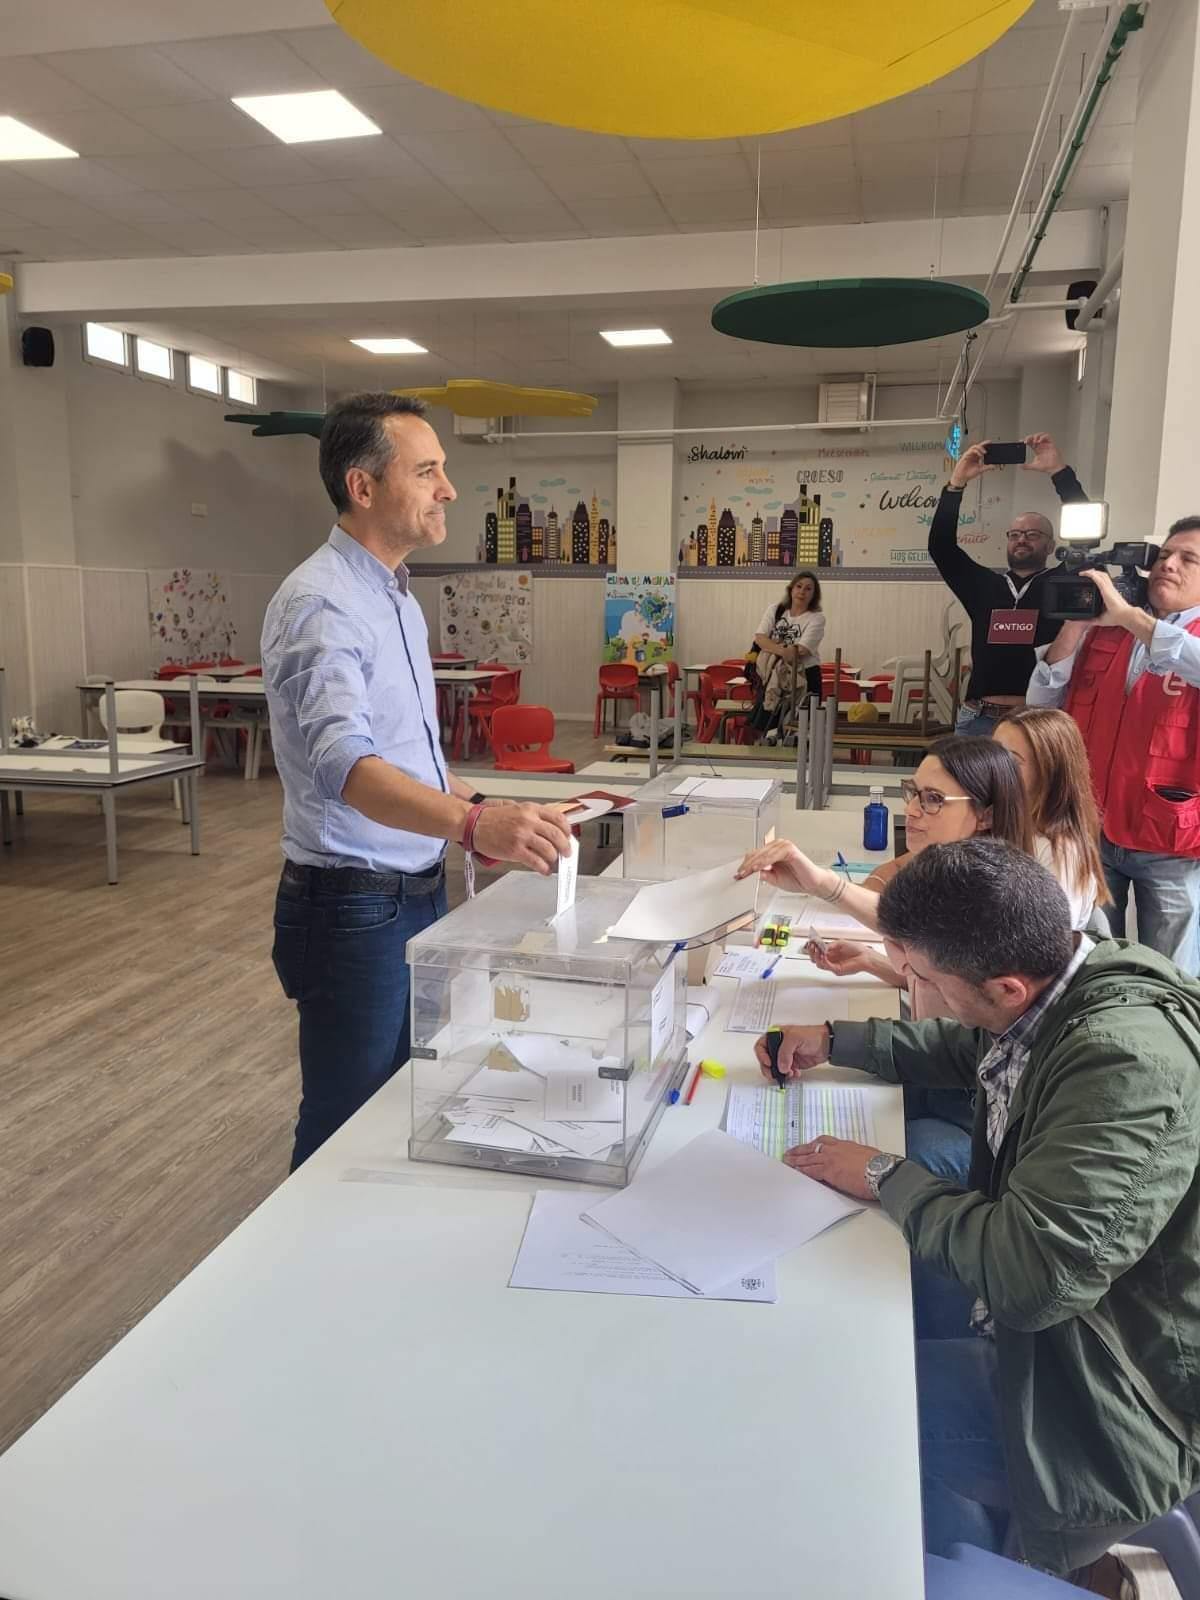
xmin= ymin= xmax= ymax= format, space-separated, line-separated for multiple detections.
xmin=1067 ymin=621 xmax=1200 ymax=858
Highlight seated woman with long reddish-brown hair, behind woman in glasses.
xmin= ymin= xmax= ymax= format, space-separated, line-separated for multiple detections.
xmin=992 ymin=706 xmax=1125 ymax=933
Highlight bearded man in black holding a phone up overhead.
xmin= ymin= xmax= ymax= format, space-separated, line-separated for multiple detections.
xmin=930 ymin=434 xmax=1088 ymax=738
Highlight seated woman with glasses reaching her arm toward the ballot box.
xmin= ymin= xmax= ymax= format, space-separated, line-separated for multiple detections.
xmin=738 ymin=734 xmax=1034 ymax=1186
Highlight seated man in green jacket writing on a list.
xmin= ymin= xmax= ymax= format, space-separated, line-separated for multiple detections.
xmin=757 ymin=838 xmax=1200 ymax=1595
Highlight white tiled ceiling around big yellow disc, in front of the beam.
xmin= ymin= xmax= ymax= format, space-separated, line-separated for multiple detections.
xmin=0 ymin=0 xmax=1139 ymax=262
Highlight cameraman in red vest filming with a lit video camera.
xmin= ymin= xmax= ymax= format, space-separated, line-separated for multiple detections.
xmin=1027 ymin=517 xmax=1200 ymax=973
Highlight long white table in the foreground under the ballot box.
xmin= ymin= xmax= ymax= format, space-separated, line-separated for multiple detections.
xmin=0 ymin=928 xmax=925 ymax=1600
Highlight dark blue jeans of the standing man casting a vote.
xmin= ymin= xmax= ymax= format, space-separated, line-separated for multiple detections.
xmin=272 ymin=882 xmax=446 ymax=1173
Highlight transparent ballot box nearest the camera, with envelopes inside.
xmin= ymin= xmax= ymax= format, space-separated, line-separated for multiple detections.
xmin=408 ymin=872 xmax=686 ymax=1187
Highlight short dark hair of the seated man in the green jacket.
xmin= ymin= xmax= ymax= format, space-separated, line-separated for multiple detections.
xmin=878 ymin=838 xmax=1074 ymax=984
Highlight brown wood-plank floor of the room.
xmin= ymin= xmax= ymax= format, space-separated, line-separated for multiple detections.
xmin=0 ymin=723 xmax=1178 ymax=1600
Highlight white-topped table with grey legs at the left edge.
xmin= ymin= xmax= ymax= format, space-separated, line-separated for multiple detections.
xmin=0 ymin=747 xmax=205 ymax=883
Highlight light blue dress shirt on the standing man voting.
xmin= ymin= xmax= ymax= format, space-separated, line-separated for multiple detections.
xmin=262 ymin=528 xmax=448 ymax=872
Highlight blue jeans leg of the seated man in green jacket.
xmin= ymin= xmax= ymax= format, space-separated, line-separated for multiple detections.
xmin=917 ymin=1338 xmax=1010 ymax=1555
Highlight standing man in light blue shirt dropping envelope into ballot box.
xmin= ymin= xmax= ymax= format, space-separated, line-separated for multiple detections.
xmin=262 ymin=394 xmax=570 ymax=1171
